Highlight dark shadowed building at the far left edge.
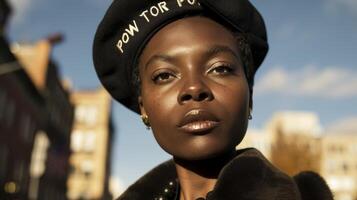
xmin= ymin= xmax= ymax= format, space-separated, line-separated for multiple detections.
xmin=0 ymin=37 xmax=45 ymax=199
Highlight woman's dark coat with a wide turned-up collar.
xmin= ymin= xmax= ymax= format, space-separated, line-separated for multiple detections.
xmin=118 ymin=148 xmax=333 ymax=200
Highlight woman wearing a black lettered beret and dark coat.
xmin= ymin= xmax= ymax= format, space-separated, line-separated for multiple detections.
xmin=93 ymin=0 xmax=332 ymax=200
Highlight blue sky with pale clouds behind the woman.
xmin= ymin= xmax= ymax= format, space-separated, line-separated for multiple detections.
xmin=7 ymin=0 xmax=357 ymax=191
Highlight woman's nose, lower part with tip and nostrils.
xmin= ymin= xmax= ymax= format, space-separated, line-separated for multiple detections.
xmin=178 ymin=79 xmax=213 ymax=104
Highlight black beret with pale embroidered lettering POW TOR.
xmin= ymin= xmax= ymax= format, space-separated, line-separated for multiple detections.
xmin=93 ymin=0 xmax=268 ymax=113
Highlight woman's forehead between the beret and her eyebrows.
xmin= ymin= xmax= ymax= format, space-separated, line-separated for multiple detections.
xmin=138 ymin=16 xmax=237 ymax=60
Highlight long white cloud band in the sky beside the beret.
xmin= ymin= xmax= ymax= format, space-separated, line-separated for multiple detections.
xmin=255 ymin=65 xmax=357 ymax=98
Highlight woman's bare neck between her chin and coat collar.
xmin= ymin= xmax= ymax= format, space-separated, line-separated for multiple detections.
xmin=174 ymin=151 xmax=235 ymax=200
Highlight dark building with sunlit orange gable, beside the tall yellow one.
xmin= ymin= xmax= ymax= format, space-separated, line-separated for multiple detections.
xmin=12 ymin=35 xmax=74 ymax=199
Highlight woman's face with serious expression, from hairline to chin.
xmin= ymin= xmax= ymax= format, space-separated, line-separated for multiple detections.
xmin=139 ymin=17 xmax=250 ymax=160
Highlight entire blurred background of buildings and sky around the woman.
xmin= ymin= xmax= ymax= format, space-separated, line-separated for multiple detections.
xmin=0 ymin=0 xmax=357 ymax=200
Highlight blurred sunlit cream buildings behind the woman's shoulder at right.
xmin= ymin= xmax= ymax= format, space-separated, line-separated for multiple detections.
xmin=238 ymin=111 xmax=357 ymax=200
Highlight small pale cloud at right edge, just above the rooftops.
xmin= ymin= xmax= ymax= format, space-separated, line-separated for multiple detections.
xmin=326 ymin=116 xmax=357 ymax=134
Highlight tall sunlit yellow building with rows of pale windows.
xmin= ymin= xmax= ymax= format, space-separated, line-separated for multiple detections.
xmin=67 ymin=88 xmax=113 ymax=199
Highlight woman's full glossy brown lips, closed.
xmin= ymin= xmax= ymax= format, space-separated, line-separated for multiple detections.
xmin=178 ymin=109 xmax=219 ymax=133
